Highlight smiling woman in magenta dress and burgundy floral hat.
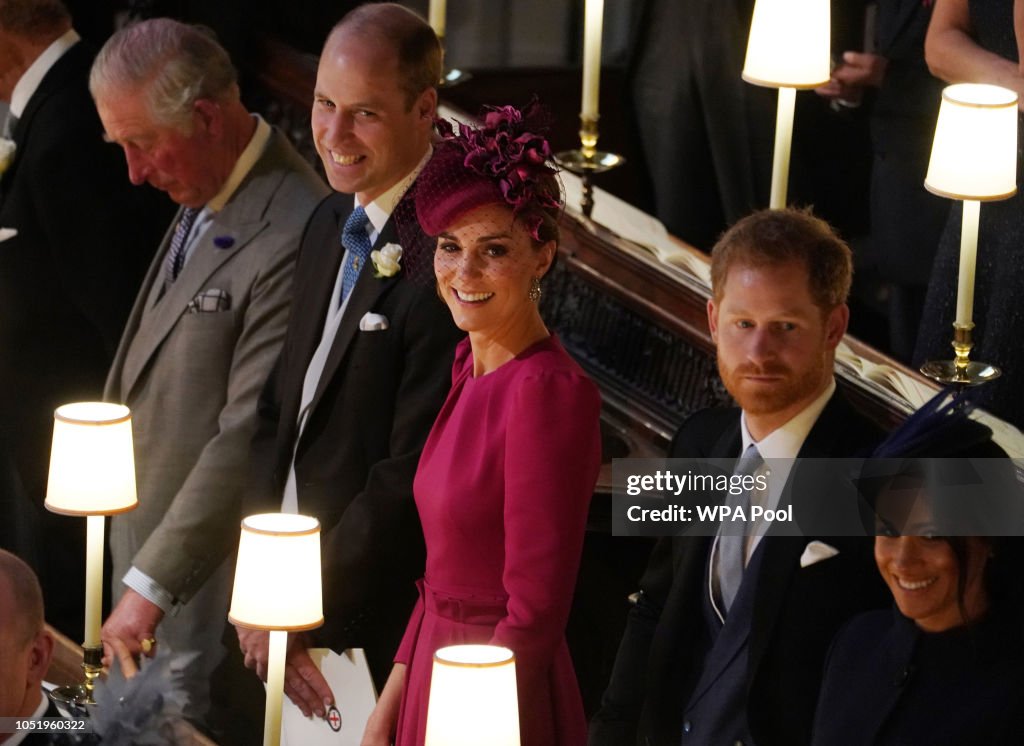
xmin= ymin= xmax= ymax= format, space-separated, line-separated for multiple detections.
xmin=362 ymin=106 xmax=601 ymax=746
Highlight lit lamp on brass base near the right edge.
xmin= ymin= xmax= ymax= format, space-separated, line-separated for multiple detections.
xmin=921 ymin=83 xmax=1017 ymax=386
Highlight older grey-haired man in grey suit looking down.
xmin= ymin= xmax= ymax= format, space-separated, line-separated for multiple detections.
xmin=89 ymin=18 xmax=327 ymax=721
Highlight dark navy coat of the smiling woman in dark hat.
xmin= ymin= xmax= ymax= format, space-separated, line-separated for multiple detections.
xmin=813 ymin=609 xmax=1024 ymax=746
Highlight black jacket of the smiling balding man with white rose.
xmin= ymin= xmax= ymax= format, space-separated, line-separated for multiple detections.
xmin=251 ymin=187 xmax=462 ymax=682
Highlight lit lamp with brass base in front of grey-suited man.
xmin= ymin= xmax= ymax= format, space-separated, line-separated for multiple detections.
xmin=45 ymin=402 xmax=138 ymax=711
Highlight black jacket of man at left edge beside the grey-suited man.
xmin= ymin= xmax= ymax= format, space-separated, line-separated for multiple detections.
xmin=0 ymin=37 xmax=174 ymax=637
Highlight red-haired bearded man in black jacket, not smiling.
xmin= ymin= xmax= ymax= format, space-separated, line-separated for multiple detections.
xmin=590 ymin=210 xmax=885 ymax=746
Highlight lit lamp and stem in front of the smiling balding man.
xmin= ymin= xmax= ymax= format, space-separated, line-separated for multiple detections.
xmin=227 ymin=513 xmax=324 ymax=746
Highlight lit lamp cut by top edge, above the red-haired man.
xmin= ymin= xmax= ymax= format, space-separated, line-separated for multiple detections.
xmin=742 ymin=0 xmax=831 ymax=210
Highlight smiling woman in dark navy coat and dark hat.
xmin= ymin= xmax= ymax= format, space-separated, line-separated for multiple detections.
xmin=813 ymin=395 xmax=1024 ymax=746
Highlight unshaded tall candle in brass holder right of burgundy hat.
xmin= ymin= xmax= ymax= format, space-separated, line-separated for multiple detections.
xmin=555 ymin=0 xmax=626 ymax=218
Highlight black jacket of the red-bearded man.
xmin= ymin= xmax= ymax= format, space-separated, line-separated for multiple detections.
xmin=590 ymin=393 xmax=887 ymax=746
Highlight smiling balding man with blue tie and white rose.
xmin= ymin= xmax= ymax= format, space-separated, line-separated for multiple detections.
xmin=239 ymin=3 xmax=462 ymax=715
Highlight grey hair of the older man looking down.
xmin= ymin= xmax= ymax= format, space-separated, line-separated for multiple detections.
xmin=89 ymin=18 xmax=240 ymax=135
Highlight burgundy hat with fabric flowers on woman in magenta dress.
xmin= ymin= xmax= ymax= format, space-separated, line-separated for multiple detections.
xmin=416 ymin=100 xmax=562 ymax=240
